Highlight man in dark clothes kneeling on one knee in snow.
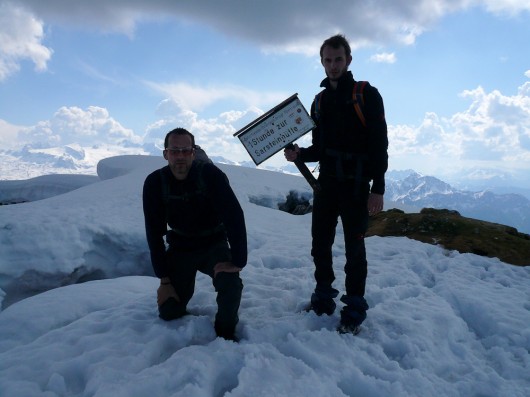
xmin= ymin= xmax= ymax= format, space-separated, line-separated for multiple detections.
xmin=143 ymin=128 xmax=247 ymax=340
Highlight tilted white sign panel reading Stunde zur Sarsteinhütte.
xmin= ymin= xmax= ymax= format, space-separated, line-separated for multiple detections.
xmin=234 ymin=94 xmax=315 ymax=165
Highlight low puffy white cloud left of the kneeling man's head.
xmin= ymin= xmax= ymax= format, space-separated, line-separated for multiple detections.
xmin=19 ymin=106 xmax=142 ymax=147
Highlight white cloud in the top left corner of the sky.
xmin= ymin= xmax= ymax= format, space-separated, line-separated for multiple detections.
xmin=0 ymin=2 xmax=52 ymax=81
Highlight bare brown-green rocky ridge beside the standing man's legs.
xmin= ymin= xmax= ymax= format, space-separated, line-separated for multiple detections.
xmin=367 ymin=208 xmax=530 ymax=266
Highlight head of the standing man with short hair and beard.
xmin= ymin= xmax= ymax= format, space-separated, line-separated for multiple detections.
xmin=320 ymin=35 xmax=352 ymax=84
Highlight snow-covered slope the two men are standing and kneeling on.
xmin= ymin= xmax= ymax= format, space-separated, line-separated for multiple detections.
xmin=0 ymin=156 xmax=530 ymax=397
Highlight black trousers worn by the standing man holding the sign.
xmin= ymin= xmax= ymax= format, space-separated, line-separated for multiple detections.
xmin=311 ymin=175 xmax=369 ymax=297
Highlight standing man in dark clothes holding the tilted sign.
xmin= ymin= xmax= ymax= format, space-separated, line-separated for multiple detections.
xmin=284 ymin=35 xmax=388 ymax=334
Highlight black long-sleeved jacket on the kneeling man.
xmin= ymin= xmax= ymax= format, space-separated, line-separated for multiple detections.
xmin=143 ymin=162 xmax=247 ymax=278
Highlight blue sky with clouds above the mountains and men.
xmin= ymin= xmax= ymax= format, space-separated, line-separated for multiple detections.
xmin=0 ymin=0 xmax=530 ymax=184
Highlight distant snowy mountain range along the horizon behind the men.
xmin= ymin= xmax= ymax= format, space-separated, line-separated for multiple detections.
xmin=0 ymin=145 xmax=530 ymax=233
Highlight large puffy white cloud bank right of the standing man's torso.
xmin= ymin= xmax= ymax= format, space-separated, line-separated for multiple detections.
xmin=389 ymin=79 xmax=530 ymax=172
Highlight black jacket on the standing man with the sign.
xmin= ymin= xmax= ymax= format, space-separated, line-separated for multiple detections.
xmin=300 ymin=72 xmax=388 ymax=194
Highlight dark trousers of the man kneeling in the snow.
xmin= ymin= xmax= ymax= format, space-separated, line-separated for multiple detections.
xmin=159 ymin=240 xmax=243 ymax=336
